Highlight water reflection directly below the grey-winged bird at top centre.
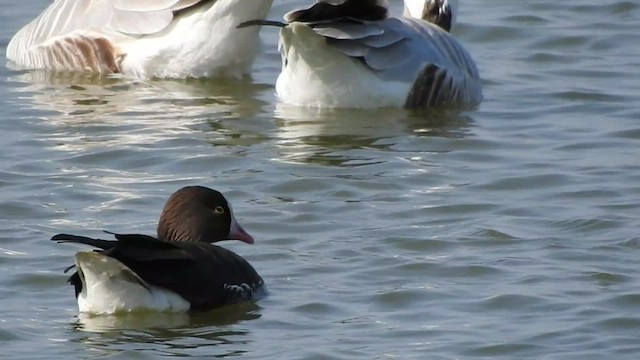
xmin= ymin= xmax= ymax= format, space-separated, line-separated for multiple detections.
xmin=275 ymin=103 xmax=473 ymax=166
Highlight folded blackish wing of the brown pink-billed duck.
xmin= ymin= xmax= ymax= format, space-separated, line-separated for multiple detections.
xmin=52 ymin=234 xmax=264 ymax=310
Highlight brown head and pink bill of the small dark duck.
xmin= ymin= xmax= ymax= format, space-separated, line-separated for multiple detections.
xmin=158 ymin=186 xmax=253 ymax=244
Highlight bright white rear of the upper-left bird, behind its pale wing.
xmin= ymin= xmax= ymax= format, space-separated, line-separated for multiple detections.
xmin=122 ymin=0 xmax=271 ymax=78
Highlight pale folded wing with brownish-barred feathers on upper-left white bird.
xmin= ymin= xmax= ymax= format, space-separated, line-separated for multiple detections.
xmin=7 ymin=0 xmax=211 ymax=70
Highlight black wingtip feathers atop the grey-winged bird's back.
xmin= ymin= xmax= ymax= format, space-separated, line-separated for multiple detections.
xmin=284 ymin=0 xmax=389 ymax=23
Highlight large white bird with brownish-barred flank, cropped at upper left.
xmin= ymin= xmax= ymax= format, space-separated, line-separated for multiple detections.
xmin=7 ymin=0 xmax=273 ymax=78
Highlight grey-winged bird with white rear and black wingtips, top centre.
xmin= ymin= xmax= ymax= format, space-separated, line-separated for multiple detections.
xmin=240 ymin=0 xmax=482 ymax=108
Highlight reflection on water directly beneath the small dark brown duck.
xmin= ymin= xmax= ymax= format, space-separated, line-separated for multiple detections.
xmin=73 ymin=302 xmax=260 ymax=357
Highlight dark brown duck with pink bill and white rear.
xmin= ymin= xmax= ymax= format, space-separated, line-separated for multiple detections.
xmin=51 ymin=186 xmax=266 ymax=314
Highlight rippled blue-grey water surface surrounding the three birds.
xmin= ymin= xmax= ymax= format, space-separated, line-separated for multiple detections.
xmin=0 ymin=0 xmax=640 ymax=359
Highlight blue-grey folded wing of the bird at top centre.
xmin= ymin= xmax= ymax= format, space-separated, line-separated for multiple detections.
xmin=311 ymin=18 xmax=481 ymax=107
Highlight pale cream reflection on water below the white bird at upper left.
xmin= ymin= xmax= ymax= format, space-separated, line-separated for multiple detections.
xmin=8 ymin=71 xmax=272 ymax=157
